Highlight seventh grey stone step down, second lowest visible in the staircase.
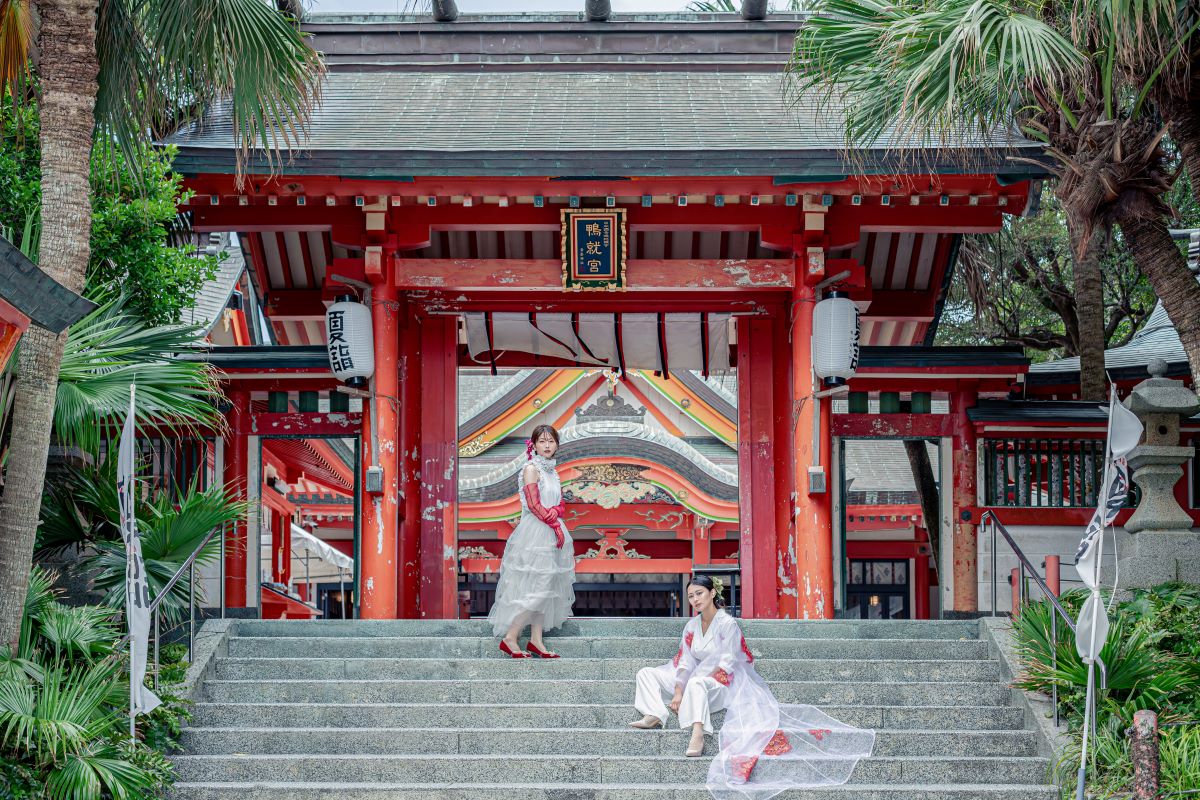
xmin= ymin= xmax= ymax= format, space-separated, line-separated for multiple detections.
xmin=173 ymin=754 xmax=1049 ymax=786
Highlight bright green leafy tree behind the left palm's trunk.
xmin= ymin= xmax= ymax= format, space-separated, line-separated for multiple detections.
xmin=0 ymin=103 xmax=218 ymax=325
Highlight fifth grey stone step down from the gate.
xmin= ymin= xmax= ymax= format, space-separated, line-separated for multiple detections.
xmin=192 ymin=697 xmax=1024 ymax=730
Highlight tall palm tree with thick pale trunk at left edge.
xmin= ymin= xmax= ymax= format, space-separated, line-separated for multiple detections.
xmin=0 ymin=0 xmax=323 ymax=646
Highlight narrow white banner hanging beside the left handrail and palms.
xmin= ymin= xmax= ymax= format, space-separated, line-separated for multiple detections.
xmin=116 ymin=384 xmax=162 ymax=724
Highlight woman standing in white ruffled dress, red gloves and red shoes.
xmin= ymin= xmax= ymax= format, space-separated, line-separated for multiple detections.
xmin=487 ymin=425 xmax=575 ymax=658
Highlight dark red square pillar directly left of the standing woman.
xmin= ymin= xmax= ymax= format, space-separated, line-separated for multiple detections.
xmin=418 ymin=317 xmax=458 ymax=619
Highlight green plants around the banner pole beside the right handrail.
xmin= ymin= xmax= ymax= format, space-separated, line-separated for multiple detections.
xmin=1013 ymin=583 xmax=1200 ymax=798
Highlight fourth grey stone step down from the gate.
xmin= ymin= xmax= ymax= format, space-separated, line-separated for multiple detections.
xmin=204 ymin=670 xmax=1012 ymax=706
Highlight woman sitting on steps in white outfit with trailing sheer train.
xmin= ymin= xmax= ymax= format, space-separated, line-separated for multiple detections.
xmin=630 ymin=575 xmax=875 ymax=800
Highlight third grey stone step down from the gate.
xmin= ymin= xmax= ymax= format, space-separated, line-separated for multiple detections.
xmin=216 ymin=654 xmax=1000 ymax=682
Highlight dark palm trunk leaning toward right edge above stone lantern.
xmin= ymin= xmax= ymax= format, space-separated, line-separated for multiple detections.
xmin=1117 ymin=208 xmax=1200 ymax=391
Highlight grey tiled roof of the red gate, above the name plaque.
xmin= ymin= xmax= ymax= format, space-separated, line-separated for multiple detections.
xmin=168 ymin=71 xmax=1036 ymax=178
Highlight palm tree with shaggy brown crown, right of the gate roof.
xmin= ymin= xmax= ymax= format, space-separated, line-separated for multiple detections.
xmin=790 ymin=0 xmax=1200 ymax=396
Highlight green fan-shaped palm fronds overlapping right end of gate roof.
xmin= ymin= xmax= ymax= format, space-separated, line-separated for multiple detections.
xmin=788 ymin=0 xmax=1085 ymax=150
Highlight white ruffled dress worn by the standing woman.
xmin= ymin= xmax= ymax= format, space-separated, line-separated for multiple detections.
xmin=487 ymin=455 xmax=575 ymax=636
